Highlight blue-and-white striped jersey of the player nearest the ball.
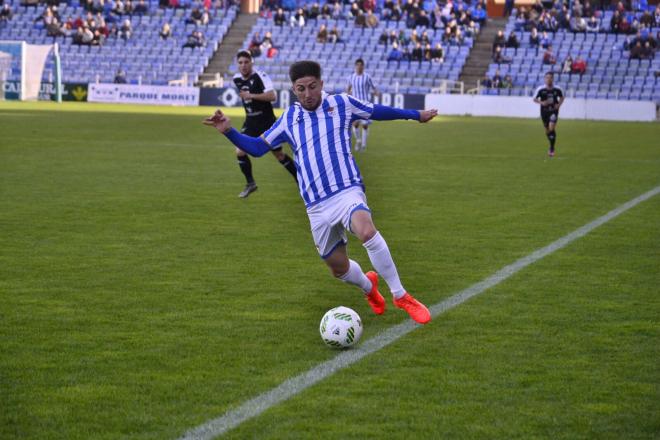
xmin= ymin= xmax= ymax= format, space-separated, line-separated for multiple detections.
xmin=263 ymin=94 xmax=374 ymax=207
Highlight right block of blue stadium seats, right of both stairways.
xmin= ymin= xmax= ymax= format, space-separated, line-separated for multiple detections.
xmin=481 ymin=3 xmax=660 ymax=103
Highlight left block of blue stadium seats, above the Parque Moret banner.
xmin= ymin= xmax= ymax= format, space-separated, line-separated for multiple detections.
xmin=0 ymin=0 xmax=237 ymax=85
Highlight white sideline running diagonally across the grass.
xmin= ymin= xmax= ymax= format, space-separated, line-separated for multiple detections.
xmin=181 ymin=186 xmax=660 ymax=440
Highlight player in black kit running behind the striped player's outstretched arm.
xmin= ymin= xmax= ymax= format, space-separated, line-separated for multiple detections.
xmin=234 ymin=50 xmax=296 ymax=198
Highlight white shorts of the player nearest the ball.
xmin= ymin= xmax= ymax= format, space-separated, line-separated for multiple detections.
xmin=307 ymin=186 xmax=371 ymax=259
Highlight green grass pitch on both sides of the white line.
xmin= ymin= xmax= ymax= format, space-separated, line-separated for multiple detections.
xmin=0 ymin=103 xmax=660 ymax=439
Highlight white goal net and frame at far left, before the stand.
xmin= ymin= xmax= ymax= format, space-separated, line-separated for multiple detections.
xmin=0 ymin=41 xmax=62 ymax=102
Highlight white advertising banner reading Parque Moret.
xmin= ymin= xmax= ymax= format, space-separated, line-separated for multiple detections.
xmin=87 ymin=83 xmax=199 ymax=106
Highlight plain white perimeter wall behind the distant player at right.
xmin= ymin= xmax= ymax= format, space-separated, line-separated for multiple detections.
xmin=425 ymin=94 xmax=656 ymax=121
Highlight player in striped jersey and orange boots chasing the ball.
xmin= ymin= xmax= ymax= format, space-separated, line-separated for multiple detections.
xmin=204 ymin=61 xmax=438 ymax=324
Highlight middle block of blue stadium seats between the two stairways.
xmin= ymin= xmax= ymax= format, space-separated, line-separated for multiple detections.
xmin=230 ymin=2 xmax=486 ymax=93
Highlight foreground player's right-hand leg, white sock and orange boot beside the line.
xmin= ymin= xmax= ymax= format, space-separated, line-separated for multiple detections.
xmin=350 ymin=205 xmax=431 ymax=324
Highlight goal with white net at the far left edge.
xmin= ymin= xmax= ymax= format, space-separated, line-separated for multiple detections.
xmin=0 ymin=41 xmax=62 ymax=102
